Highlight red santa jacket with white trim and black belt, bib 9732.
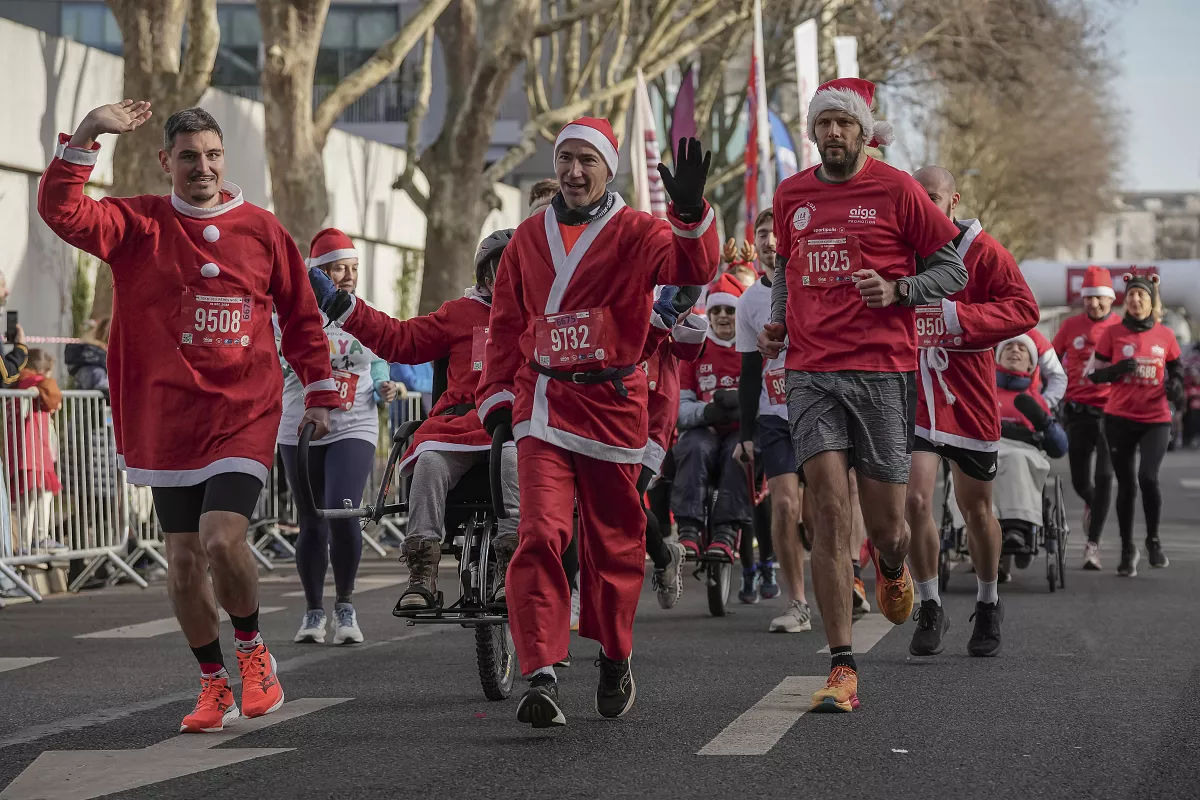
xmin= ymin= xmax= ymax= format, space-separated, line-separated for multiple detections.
xmin=476 ymin=196 xmax=719 ymax=464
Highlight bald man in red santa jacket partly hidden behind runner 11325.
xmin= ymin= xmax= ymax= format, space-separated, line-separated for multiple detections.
xmin=905 ymin=167 xmax=1038 ymax=656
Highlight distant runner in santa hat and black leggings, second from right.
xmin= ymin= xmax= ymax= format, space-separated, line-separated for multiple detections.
xmin=1054 ymin=266 xmax=1121 ymax=570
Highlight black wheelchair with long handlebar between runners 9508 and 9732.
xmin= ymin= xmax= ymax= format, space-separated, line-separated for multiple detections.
xmin=296 ymin=361 xmax=518 ymax=700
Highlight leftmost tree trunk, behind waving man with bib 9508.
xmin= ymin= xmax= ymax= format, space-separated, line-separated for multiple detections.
xmin=90 ymin=0 xmax=221 ymax=319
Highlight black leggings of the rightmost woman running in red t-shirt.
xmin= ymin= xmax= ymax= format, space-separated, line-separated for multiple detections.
xmin=1104 ymin=414 xmax=1171 ymax=547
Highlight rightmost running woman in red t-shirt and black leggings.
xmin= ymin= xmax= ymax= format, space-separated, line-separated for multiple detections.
xmin=1090 ymin=273 xmax=1183 ymax=577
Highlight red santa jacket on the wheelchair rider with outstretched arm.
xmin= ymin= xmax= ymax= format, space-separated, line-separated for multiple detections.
xmin=342 ymin=290 xmax=492 ymax=474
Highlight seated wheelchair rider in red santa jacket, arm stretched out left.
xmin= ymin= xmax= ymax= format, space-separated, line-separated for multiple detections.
xmin=308 ymin=228 xmax=520 ymax=610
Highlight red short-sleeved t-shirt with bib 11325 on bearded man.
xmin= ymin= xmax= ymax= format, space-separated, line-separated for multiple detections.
xmin=772 ymin=158 xmax=959 ymax=372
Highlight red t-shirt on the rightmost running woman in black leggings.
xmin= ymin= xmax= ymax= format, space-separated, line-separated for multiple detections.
xmin=1096 ymin=325 xmax=1181 ymax=423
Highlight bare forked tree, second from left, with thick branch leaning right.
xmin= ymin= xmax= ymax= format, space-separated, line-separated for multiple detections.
xmin=257 ymin=0 xmax=451 ymax=242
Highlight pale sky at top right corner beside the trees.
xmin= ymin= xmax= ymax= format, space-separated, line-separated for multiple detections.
xmin=1108 ymin=0 xmax=1200 ymax=191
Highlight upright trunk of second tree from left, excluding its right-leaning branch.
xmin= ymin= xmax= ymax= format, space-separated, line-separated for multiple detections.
xmin=258 ymin=0 xmax=329 ymax=248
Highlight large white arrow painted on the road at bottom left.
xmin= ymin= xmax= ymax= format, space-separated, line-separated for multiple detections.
xmin=0 ymin=697 xmax=353 ymax=800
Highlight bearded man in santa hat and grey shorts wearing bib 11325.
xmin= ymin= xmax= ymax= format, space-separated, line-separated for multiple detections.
xmin=758 ymin=78 xmax=967 ymax=711
